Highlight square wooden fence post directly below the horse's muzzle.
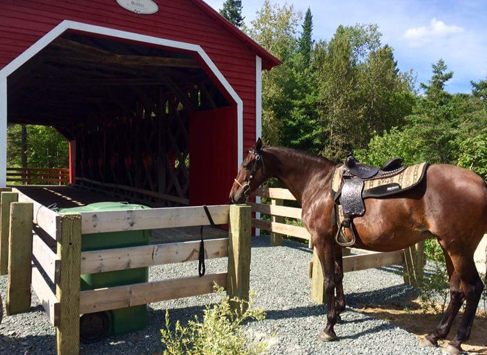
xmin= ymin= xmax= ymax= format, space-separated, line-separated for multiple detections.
xmin=227 ymin=205 xmax=252 ymax=311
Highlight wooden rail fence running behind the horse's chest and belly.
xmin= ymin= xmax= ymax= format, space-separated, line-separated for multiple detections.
xmin=249 ymin=188 xmax=426 ymax=304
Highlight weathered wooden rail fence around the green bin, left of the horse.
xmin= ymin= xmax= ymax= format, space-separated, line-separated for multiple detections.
xmin=0 ymin=189 xmax=251 ymax=355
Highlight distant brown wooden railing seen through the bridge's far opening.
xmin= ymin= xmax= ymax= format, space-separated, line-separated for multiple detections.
xmin=7 ymin=168 xmax=69 ymax=185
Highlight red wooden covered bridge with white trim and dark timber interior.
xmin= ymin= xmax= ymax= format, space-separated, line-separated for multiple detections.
xmin=0 ymin=0 xmax=279 ymax=206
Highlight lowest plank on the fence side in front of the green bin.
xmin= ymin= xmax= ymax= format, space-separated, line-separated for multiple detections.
xmin=80 ymin=273 xmax=227 ymax=314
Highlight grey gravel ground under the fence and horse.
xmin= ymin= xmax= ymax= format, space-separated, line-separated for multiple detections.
xmin=0 ymin=237 xmax=482 ymax=355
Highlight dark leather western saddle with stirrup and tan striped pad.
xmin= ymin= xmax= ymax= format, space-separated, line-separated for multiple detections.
xmin=332 ymin=153 xmax=428 ymax=246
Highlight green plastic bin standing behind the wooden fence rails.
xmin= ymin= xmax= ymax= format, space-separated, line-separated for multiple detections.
xmin=59 ymin=202 xmax=151 ymax=334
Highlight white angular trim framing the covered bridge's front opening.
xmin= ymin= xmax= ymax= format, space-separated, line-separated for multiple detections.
xmin=0 ymin=20 xmax=243 ymax=187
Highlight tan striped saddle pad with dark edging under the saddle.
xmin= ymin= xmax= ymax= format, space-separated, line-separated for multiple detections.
xmin=331 ymin=163 xmax=429 ymax=199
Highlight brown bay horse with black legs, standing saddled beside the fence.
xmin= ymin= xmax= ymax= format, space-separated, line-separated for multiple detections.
xmin=230 ymin=139 xmax=487 ymax=354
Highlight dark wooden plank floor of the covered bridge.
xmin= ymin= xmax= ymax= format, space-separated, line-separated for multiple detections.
xmin=10 ymin=186 xmax=228 ymax=243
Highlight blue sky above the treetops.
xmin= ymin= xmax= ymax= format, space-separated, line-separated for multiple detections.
xmin=205 ymin=0 xmax=487 ymax=93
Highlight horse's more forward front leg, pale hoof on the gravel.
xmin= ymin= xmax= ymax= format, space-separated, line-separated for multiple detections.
xmin=316 ymin=239 xmax=337 ymax=342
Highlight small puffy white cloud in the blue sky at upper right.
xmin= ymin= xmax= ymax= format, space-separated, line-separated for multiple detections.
xmin=403 ymin=18 xmax=465 ymax=47
